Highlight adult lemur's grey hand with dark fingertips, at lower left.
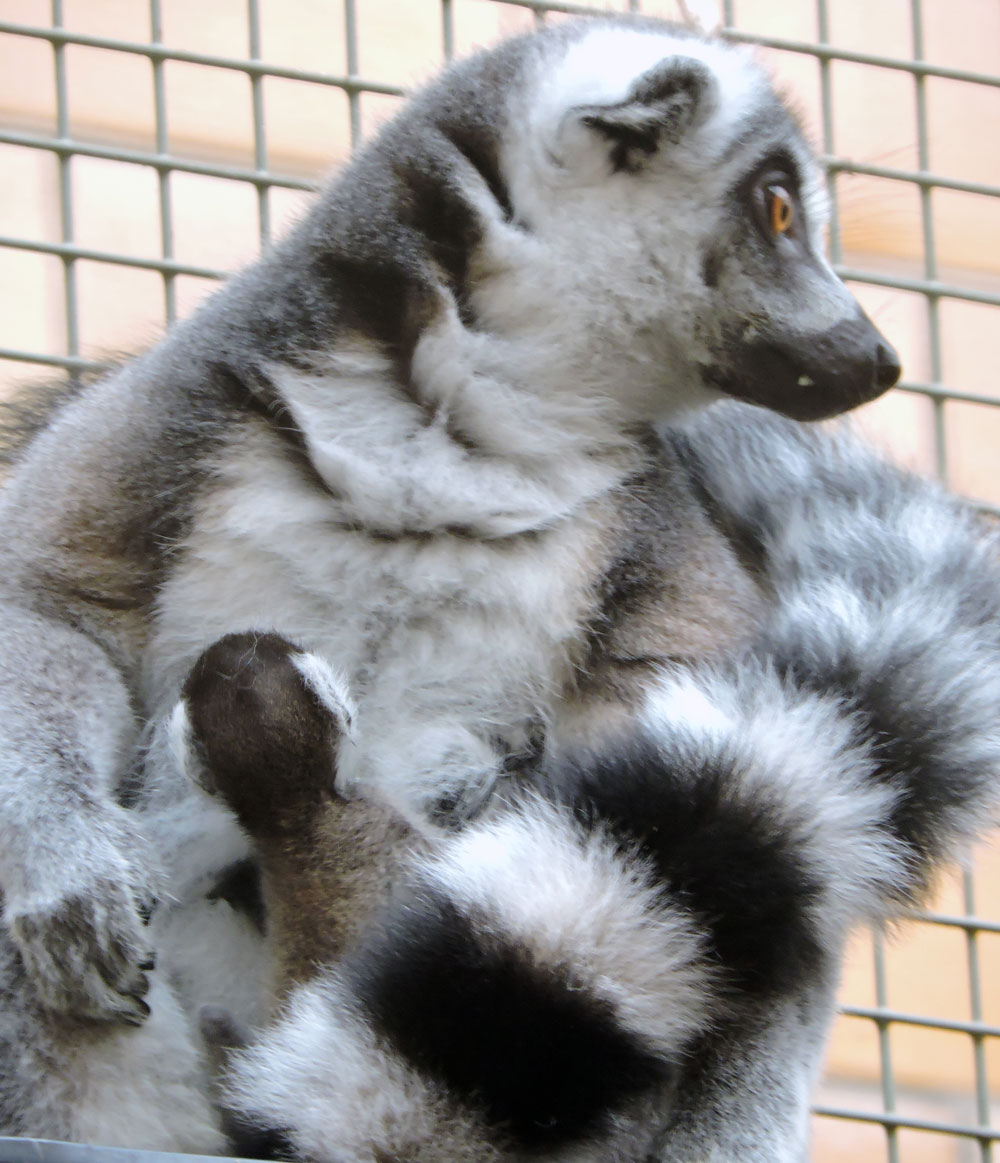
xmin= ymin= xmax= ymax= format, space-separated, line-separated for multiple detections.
xmin=6 ymin=818 xmax=156 ymax=1026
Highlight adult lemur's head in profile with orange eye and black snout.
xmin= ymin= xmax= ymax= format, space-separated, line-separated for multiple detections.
xmin=507 ymin=23 xmax=900 ymax=419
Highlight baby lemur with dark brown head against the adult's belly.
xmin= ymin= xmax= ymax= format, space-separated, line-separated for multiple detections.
xmin=173 ymin=633 xmax=415 ymax=994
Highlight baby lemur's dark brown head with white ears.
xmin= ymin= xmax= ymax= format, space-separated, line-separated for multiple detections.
xmin=170 ymin=633 xmax=355 ymax=835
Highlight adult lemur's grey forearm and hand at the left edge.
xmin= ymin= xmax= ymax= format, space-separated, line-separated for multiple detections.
xmin=0 ymin=607 xmax=156 ymax=1025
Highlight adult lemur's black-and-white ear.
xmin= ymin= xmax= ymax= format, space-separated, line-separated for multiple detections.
xmin=572 ymin=57 xmax=717 ymax=173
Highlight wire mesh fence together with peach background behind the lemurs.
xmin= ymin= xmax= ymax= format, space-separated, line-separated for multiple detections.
xmin=0 ymin=0 xmax=1000 ymax=1163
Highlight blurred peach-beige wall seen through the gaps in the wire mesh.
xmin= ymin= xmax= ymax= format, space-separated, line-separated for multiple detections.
xmin=0 ymin=0 xmax=1000 ymax=1163
